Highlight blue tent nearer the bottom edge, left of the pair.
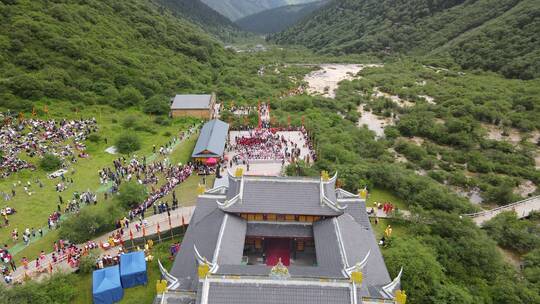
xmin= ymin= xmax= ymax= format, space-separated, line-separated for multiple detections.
xmin=92 ymin=266 xmax=124 ymax=304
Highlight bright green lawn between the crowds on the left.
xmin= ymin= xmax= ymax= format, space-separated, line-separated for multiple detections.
xmin=0 ymin=104 xmax=197 ymax=258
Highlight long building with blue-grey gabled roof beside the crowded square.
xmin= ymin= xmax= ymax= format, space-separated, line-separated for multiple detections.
xmin=191 ymin=119 xmax=229 ymax=160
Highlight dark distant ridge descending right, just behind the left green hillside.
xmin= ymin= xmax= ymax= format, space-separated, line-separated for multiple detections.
xmin=157 ymin=0 xmax=246 ymax=42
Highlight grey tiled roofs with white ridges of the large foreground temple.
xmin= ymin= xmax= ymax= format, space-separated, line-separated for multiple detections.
xmin=170 ymin=177 xmax=399 ymax=303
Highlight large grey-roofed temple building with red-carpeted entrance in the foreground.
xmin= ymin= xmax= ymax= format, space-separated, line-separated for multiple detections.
xmin=161 ymin=172 xmax=406 ymax=304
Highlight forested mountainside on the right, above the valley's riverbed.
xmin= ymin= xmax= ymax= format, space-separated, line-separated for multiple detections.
xmin=273 ymin=0 xmax=540 ymax=79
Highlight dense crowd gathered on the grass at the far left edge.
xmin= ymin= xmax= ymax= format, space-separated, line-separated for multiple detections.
xmin=0 ymin=116 xmax=97 ymax=178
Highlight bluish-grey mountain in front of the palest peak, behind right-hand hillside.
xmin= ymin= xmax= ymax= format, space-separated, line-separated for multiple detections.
xmin=236 ymin=0 xmax=328 ymax=34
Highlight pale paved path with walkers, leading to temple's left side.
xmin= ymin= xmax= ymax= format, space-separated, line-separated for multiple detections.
xmin=7 ymin=206 xmax=195 ymax=282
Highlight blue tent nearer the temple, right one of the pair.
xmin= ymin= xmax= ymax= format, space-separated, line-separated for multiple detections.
xmin=120 ymin=251 xmax=148 ymax=288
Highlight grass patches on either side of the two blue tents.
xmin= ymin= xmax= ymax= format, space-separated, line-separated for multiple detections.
xmin=72 ymin=238 xmax=181 ymax=304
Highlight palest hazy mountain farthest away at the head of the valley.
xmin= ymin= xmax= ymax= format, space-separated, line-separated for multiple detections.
xmin=202 ymin=0 xmax=318 ymax=21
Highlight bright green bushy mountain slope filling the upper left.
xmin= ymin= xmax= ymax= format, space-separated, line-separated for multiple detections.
xmin=0 ymin=0 xmax=226 ymax=109
